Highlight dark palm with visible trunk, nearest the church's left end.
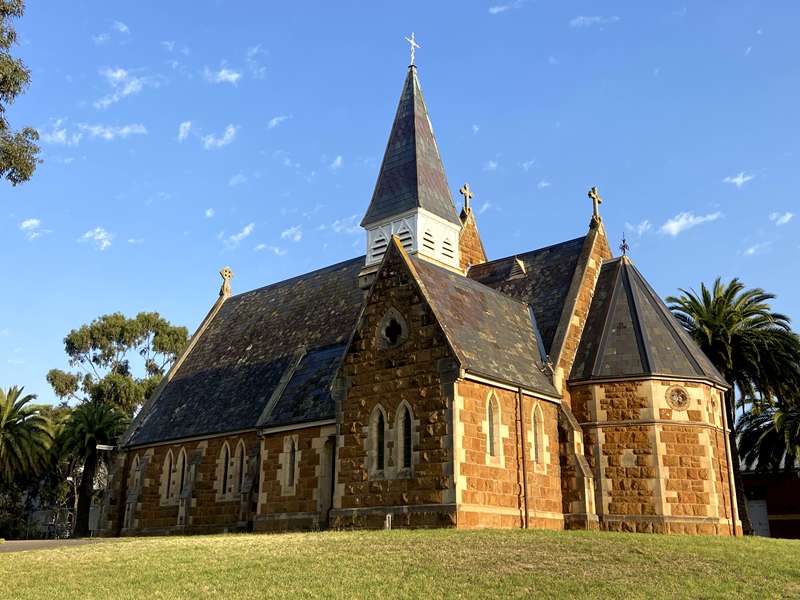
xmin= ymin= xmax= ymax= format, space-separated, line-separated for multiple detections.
xmin=61 ymin=402 xmax=128 ymax=537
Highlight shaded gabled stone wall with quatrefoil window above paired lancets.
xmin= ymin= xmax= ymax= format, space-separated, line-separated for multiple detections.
xmin=333 ymin=246 xmax=457 ymax=527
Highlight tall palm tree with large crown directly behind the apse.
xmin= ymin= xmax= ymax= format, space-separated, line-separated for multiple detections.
xmin=667 ymin=278 xmax=800 ymax=533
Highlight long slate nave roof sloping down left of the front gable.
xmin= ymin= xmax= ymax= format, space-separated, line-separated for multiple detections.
xmin=125 ymin=257 xmax=364 ymax=445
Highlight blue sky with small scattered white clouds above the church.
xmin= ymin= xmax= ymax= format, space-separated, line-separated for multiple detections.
xmin=0 ymin=0 xmax=800 ymax=401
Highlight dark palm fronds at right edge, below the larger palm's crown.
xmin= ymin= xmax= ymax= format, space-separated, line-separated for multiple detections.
xmin=736 ymin=404 xmax=800 ymax=471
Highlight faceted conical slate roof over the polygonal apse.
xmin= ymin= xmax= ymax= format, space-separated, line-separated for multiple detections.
xmin=570 ymin=257 xmax=727 ymax=385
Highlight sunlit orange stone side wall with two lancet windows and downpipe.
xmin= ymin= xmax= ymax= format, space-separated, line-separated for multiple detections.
xmin=454 ymin=380 xmax=564 ymax=529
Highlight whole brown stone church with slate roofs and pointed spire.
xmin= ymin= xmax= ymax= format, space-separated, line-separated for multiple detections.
xmin=101 ymin=57 xmax=741 ymax=536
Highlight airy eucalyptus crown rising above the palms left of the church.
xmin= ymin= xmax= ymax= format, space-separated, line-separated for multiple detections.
xmin=47 ymin=312 xmax=188 ymax=414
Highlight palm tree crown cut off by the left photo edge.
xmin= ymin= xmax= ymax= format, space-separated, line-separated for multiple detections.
xmin=0 ymin=386 xmax=53 ymax=483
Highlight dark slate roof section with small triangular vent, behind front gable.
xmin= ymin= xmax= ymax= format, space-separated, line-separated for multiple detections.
xmin=467 ymin=237 xmax=586 ymax=354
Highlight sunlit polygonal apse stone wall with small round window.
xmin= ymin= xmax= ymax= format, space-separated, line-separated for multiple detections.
xmin=572 ymin=380 xmax=738 ymax=535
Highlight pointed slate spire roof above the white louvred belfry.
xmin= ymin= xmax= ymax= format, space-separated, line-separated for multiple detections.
xmin=361 ymin=66 xmax=461 ymax=227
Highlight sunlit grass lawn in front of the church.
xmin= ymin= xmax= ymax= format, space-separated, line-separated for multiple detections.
xmin=0 ymin=530 xmax=800 ymax=600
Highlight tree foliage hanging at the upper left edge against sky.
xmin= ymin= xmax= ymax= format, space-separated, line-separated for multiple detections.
xmin=0 ymin=0 xmax=41 ymax=185
